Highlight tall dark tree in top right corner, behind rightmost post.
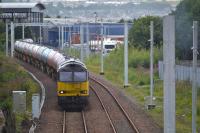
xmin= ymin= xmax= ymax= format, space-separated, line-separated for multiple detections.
xmin=172 ymin=0 xmax=200 ymax=60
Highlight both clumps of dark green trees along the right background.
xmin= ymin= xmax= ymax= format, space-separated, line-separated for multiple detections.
xmin=129 ymin=0 xmax=200 ymax=60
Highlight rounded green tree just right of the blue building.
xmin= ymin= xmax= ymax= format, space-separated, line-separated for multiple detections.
xmin=129 ymin=16 xmax=162 ymax=49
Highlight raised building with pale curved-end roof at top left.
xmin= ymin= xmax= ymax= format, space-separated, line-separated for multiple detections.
xmin=0 ymin=3 xmax=45 ymax=23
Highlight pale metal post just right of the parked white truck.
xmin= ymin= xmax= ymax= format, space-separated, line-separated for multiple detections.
xmin=124 ymin=22 xmax=129 ymax=87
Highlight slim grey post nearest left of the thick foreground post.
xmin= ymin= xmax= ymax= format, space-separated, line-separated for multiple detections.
xmin=148 ymin=21 xmax=155 ymax=109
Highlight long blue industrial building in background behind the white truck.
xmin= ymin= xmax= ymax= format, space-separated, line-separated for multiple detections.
xmin=48 ymin=23 xmax=132 ymax=46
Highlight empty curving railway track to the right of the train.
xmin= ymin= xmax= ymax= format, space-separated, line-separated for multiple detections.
xmin=90 ymin=77 xmax=140 ymax=133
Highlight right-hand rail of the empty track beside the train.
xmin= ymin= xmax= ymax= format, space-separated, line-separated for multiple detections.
xmin=89 ymin=77 xmax=140 ymax=133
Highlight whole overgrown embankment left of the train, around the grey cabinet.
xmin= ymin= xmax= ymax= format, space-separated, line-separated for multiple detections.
xmin=0 ymin=53 xmax=40 ymax=133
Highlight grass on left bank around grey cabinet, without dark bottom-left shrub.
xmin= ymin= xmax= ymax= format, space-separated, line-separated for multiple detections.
xmin=0 ymin=53 xmax=39 ymax=132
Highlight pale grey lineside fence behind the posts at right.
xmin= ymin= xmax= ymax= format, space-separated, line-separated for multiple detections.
xmin=158 ymin=61 xmax=200 ymax=87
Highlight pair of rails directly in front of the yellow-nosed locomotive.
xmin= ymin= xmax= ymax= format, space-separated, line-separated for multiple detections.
xmin=62 ymin=111 xmax=88 ymax=133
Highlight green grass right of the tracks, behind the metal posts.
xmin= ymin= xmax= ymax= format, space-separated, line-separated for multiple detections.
xmin=85 ymin=48 xmax=200 ymax=133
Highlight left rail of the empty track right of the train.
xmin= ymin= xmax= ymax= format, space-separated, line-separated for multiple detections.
xmin=90 ymin=85 xmax=117 ymax=133
